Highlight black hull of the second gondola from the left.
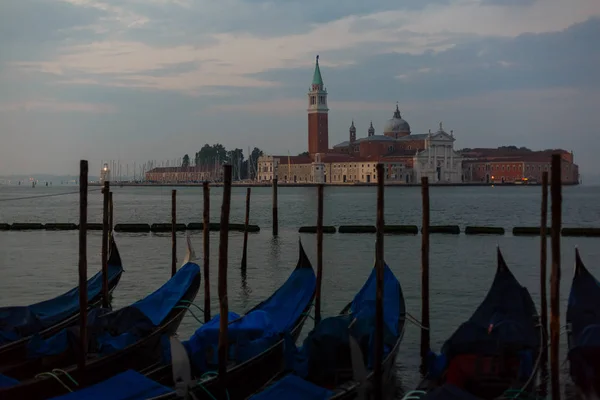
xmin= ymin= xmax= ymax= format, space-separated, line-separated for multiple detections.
xmin=0 ymin=274 xmax=200 ymax=400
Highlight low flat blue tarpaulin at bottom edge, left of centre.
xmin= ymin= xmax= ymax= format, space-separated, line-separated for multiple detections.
xmin=51 ymin=370 xmax=173 ymax=400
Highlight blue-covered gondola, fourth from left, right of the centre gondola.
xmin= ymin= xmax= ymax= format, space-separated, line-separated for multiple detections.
xmin=250 ymin=265 xmax=406 ymax=400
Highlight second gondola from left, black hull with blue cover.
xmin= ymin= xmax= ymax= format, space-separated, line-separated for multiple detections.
xmin=0 ymin=242 xmax=200 ymax=400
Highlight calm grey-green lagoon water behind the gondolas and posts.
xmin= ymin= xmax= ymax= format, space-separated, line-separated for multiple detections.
xmin=0 ymin=186 xmax=600 ymax=396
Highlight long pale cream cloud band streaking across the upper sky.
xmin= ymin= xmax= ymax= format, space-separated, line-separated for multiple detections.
xmin=8 ymin=0 xmax=600 ymax=94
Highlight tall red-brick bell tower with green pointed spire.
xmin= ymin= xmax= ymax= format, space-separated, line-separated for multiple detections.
xmin=307 ymin=56 xmax=329 ymax=155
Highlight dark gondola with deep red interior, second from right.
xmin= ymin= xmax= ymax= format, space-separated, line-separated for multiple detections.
xmin=404 ymin=249 xmax=543 ymax=400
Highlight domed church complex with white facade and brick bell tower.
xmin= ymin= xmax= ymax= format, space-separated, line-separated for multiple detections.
xmin=257 ymin=56 xmax=463 ymax=184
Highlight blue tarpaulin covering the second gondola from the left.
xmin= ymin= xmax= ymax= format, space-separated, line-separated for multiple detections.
xmin=27 ymin=263 xmax=200 ymax=359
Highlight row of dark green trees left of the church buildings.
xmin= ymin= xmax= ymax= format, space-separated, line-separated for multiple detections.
xmin=181 ymin=143 xmax=263 ymax=180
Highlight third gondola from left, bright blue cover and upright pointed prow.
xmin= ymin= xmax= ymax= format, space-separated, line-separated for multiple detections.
xmin=47 ymin=243 xmax=316 ymax=400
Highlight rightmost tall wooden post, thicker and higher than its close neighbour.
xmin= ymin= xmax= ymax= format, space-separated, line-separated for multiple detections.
xmin=550 ymin=154 xmax=562 ymax=400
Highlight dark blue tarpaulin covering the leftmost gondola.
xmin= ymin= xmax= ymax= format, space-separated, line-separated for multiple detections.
xmin=0 ymin=263 xmax=123 ymax=345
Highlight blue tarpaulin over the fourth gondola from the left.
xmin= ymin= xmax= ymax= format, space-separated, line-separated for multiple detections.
xmin=293 ymin=265 xmax=405 ymax=382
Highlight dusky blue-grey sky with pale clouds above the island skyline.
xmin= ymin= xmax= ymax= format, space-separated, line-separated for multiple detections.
xmin=0 ymin=0 xmax=600 ymax=177
